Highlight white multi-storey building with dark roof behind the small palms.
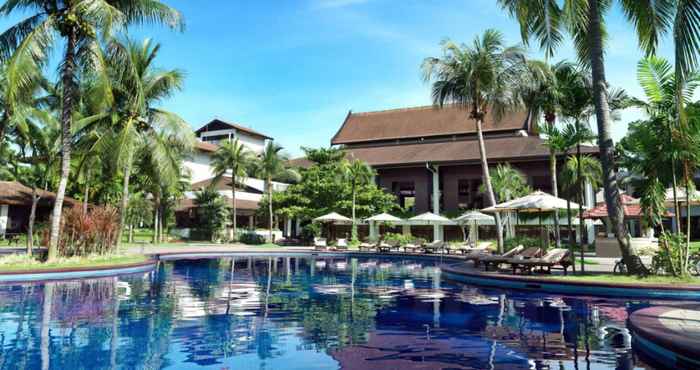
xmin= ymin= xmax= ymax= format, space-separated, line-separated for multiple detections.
xmin=177 ymin=119 xmax=288 ymax=237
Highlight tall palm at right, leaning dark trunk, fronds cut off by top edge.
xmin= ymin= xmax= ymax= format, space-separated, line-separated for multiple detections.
xmin=499 ymin=0 xmax=700 ymax=274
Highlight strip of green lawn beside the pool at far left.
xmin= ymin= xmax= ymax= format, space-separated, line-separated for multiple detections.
xmin=0 ymin=254 xmax=148 ymax=272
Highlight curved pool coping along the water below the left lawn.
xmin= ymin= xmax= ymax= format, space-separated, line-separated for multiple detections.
xmin=0 ymin=257 xmax=158 ymax=284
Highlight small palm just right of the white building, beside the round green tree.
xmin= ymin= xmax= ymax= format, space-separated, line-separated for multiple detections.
xmin=255 ymin=141 xmax=296 ymax=243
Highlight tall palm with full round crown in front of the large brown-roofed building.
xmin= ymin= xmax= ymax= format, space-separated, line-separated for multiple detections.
xmin=422 ymin=29 xmax=525 ymax=252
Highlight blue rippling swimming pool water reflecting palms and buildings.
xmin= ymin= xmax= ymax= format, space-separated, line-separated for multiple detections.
xmin=0 ymin=256 xmax=681 ymax=370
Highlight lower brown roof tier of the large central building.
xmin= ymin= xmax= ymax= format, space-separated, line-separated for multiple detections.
xmin=345 ymin=136 xmax=599 ymax=166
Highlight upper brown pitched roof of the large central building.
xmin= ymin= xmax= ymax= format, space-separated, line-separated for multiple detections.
xmin=331 ymin=105 xmax=527 ymax=145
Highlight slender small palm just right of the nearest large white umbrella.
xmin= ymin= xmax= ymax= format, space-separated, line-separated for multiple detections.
xmin=562 ymin=156 xmax=603 ymax=272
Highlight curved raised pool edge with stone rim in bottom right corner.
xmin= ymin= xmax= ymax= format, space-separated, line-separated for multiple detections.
xmin=627 ymin=306 xmax=700 ymax=369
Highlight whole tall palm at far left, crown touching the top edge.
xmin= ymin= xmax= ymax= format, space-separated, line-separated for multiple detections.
xmin=0 ymin=0 xmax=183 ymax=261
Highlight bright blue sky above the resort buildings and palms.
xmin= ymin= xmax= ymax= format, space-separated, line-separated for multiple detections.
xmin=0 ymin=0 xmax=671 ymax=155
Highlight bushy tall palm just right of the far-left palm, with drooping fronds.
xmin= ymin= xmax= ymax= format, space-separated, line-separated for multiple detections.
xmin=84 ymin=39 xmax=195 ymax=247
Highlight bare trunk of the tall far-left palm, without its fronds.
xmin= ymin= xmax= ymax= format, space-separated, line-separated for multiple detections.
xmin=47 ymin=29 xmax=78 ymax=262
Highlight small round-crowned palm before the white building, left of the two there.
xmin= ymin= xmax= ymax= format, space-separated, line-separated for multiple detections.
xmin=212 ymin=139 xmax=253 ymax=240
